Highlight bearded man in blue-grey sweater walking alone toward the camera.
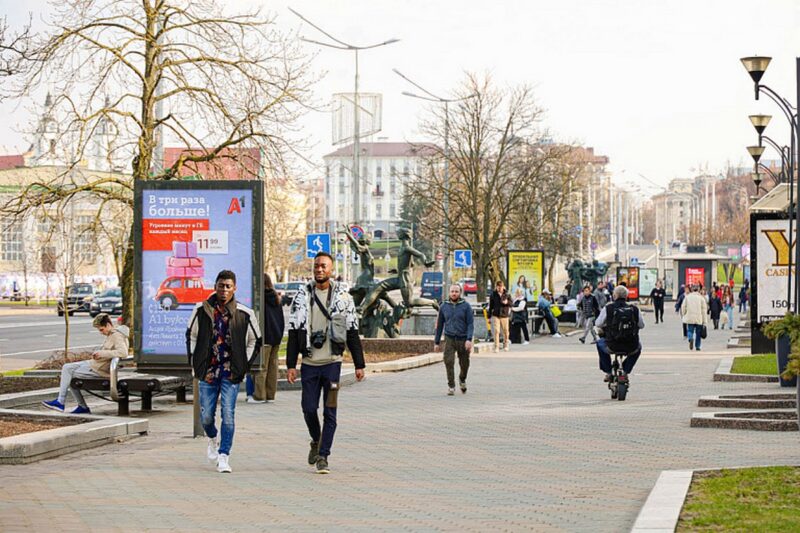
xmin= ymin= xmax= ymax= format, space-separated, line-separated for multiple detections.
xmin=433 ymin=284 xmax=474 ymax=396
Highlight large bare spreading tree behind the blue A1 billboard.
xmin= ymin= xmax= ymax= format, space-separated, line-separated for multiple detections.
xmin=4 ymin=0 xmax=313 ymax=325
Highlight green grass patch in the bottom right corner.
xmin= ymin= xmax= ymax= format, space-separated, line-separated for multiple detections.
xmin=676 ymin=466 xmax=800 ymax=532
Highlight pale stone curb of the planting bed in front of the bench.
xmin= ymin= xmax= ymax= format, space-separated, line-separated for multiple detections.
xmin=0 ymin=409 xmax=149 ymax=464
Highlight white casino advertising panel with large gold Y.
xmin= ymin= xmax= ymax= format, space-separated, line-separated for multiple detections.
xmin=755 ymin=220 xmax=794 ymax=322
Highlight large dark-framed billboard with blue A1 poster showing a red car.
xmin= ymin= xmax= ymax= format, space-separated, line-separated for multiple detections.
xmin=134 ymin=180 xmax=263 ymax=365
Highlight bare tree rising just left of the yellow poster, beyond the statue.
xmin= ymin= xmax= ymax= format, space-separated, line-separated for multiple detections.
xmin=409 ymin=74 xmax=562 ymax=299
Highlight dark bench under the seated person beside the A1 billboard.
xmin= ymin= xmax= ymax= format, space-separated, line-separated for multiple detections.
xmin=70 ymin=357 xmax=187 ymax=416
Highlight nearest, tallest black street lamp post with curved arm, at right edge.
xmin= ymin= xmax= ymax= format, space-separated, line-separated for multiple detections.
xmin=741 ymin=56 xmax=800 ymax=308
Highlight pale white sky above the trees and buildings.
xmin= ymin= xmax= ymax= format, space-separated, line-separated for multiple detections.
xmin=0 ymin=0 xmax=800 ymax=192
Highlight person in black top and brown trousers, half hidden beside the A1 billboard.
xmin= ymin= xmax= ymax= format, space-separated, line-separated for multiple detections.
xmin=247 ymin=273 xmax=285 ymax=403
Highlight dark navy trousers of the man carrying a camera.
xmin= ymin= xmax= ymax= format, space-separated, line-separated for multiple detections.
xmin=300 ymin=363 xmax=342 ymax=457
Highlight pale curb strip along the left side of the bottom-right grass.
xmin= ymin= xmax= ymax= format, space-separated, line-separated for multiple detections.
xmin=631 ymin=470 xmax=694 ymax=533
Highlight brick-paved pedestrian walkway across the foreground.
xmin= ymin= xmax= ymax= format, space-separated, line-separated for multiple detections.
xmin=0 ymin=308 xmax=800 ymax=531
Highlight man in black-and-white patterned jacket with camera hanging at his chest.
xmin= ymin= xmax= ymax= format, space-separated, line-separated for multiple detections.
xmin=286 ymin=252 xmax=365 ymax=474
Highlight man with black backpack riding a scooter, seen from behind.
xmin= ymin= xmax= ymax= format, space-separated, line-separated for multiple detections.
xmin=595 ymin=285 xmax=644 ymax=383
